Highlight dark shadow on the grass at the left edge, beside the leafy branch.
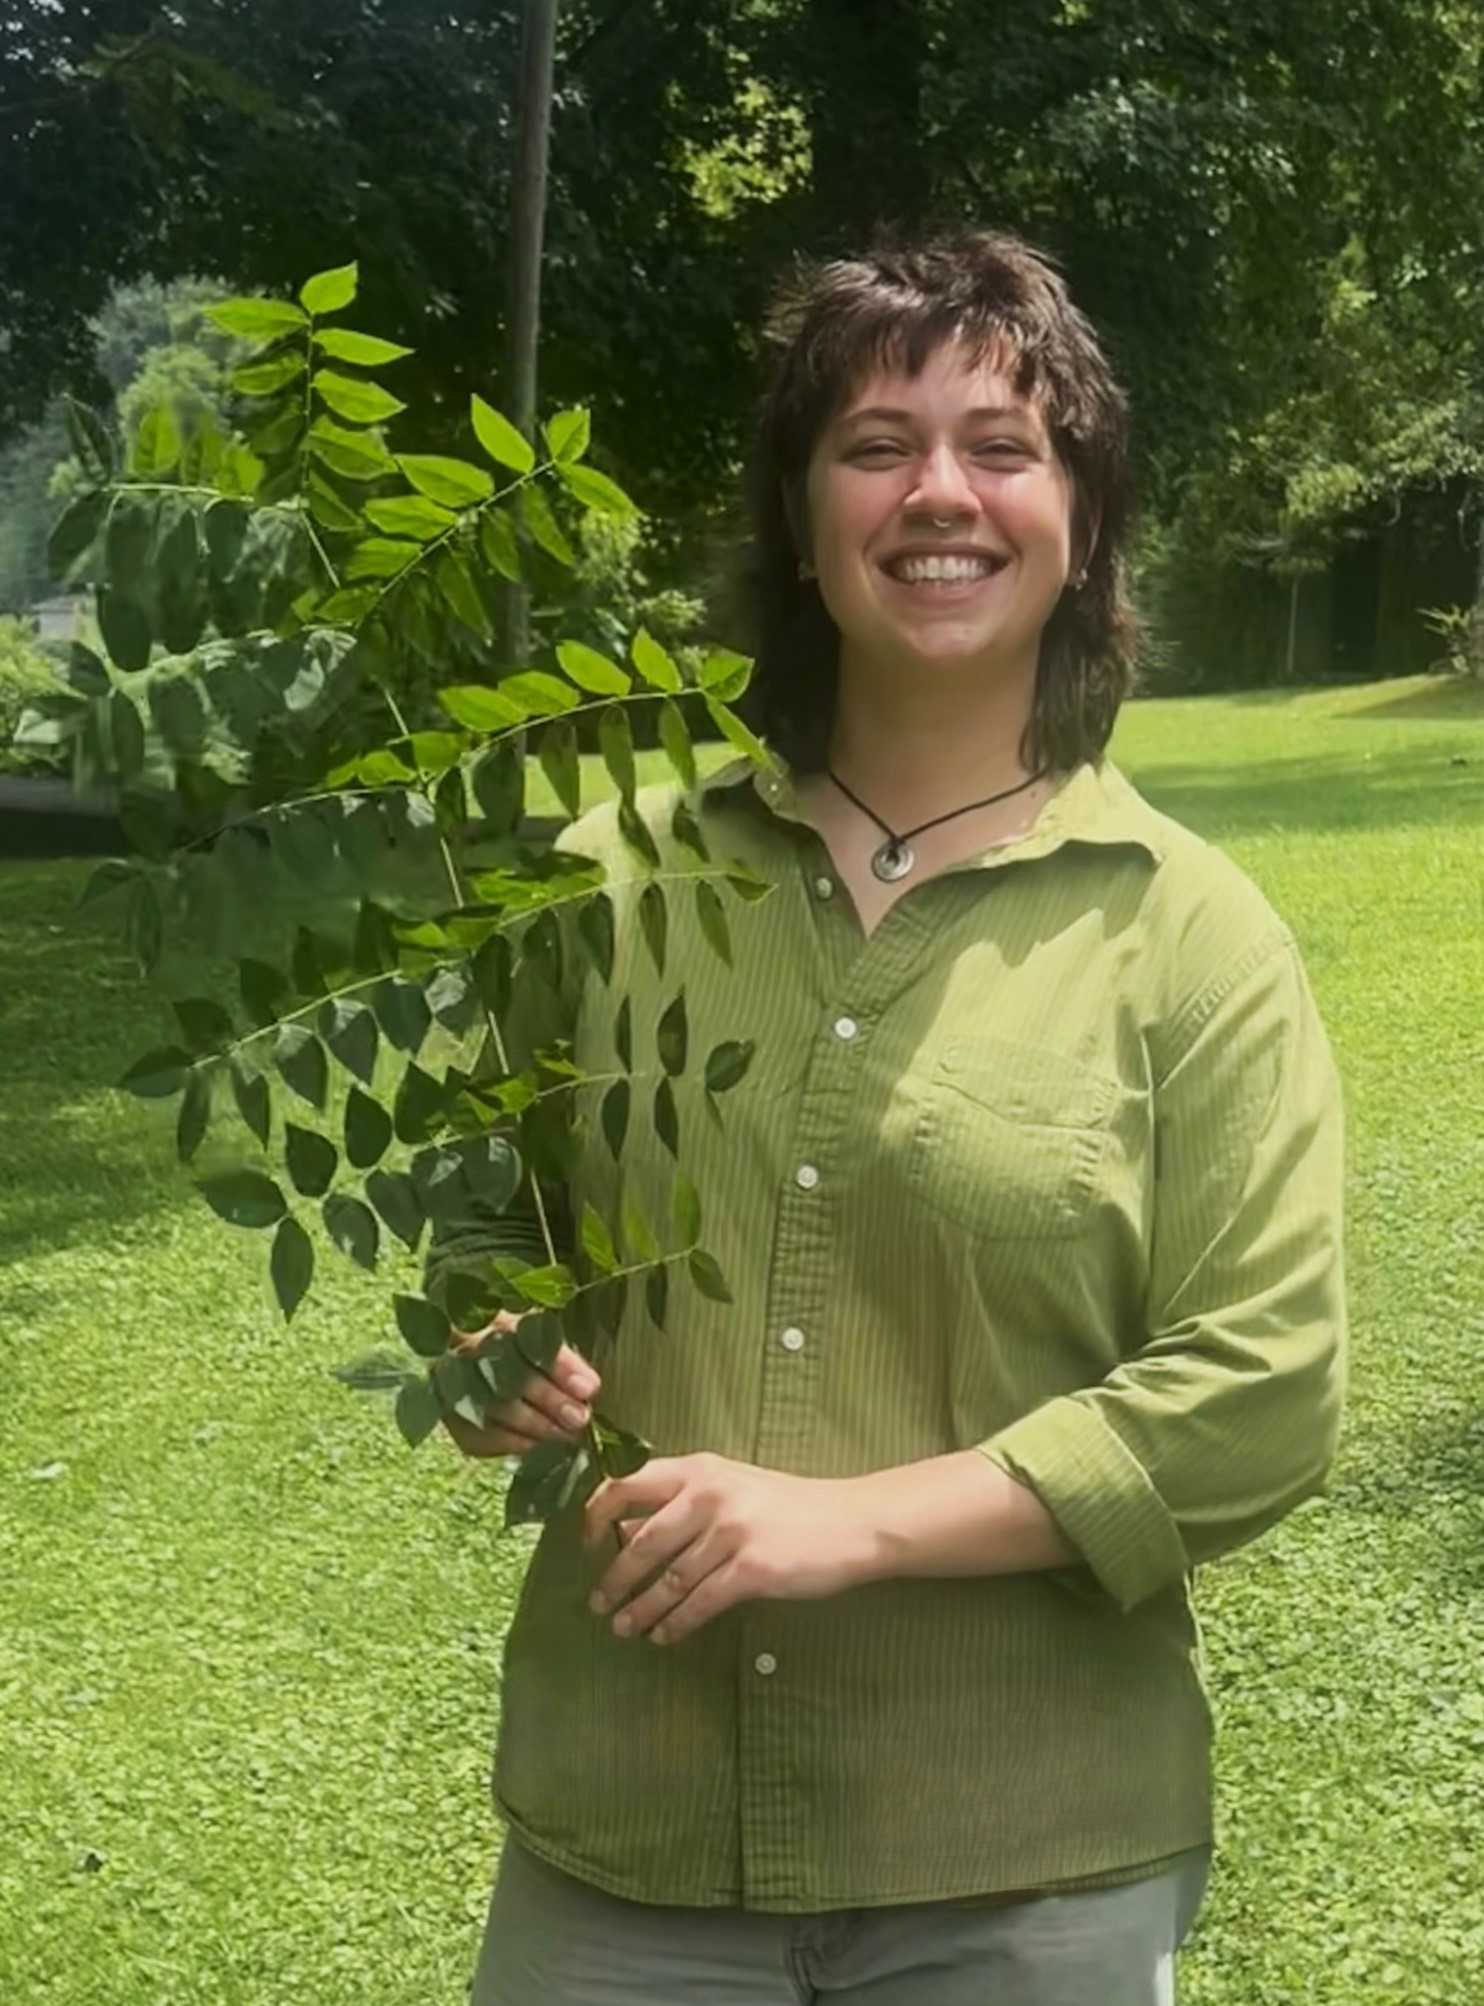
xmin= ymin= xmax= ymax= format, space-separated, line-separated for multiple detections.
xmin=0 ymin=863 xmax=189 ymax=1266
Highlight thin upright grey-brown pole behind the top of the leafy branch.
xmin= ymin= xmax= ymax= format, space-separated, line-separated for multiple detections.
xmin=505 ymin=0 xmax=558 ymax=666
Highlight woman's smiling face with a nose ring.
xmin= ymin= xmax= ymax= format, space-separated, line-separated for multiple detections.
xmin=806 ymin=341 xmax=1073 ymax=676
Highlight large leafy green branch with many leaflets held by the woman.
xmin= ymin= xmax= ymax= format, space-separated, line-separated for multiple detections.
xmin=16 ymin=265 xmax=768 ymax=1517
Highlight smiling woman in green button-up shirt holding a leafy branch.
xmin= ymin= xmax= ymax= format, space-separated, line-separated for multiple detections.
xmin=437 ymin=235 xmax=1344 ymax=2006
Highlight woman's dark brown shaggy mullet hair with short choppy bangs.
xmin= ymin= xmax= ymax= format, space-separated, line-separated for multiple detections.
xmin=744 ymin=231 xmax=1135 ymax=770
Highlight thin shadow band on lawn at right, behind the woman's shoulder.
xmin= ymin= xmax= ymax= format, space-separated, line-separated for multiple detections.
xmin=1129 ymin=740 xmax=1484 ymax=839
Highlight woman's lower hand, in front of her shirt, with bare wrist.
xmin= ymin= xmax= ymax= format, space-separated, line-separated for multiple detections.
xmin=586 ymin=1454 xmax=872 ymax=1643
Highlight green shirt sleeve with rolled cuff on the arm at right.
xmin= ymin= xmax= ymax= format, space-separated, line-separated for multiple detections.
xmin=981 ymin=935 xmax=1346 ymax=1609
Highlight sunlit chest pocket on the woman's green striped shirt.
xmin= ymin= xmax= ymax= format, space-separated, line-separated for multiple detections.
xmin=908 ymin=1037 xmax=1117 ymax=1240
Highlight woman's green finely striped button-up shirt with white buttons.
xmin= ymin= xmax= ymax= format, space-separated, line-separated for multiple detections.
xmin=437 ymin=760 xmax=1344 ymax=1912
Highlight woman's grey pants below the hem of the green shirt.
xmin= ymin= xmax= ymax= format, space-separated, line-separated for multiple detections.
xmin=471 ymin=1840 xmax=1209 ymax=2006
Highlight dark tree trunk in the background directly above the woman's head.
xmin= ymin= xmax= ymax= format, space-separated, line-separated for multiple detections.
xmin=806 ymin=0 xmax=929 ymax=249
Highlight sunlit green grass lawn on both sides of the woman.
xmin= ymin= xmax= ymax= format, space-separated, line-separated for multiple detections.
xmin=0 ymin=678 xmax=1484 ymax=2006
